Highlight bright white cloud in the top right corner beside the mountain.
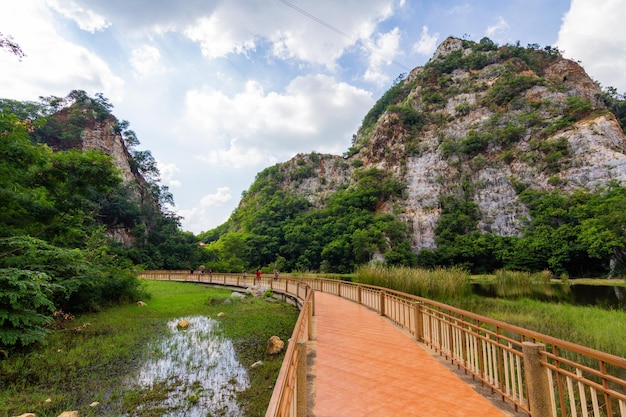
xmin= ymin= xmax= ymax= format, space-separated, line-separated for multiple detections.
xmin=556 ymin=0 xmax=626 ymax=93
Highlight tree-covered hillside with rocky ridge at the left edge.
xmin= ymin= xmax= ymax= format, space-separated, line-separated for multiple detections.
xmin=0 ymin=91 xmax=210 ymax=351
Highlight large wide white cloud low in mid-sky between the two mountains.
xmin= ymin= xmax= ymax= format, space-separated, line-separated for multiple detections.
xmin=185 ymin=74 xmax=372 ymax=158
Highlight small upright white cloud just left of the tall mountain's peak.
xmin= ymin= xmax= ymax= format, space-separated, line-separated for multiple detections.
xmin=363 ymin=27 xmax=400 ymax=86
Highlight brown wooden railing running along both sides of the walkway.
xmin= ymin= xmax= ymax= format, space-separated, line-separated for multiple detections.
xmin=143 ymin=271 xmax=626 ymax=417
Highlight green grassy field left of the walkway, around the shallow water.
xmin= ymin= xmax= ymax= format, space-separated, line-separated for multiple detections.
xmin=0 ymin=281 xmax=298 ymax=417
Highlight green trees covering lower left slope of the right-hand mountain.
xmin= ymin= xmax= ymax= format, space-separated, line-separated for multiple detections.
xmin=207 ymin=169 xmax=414 ymax=273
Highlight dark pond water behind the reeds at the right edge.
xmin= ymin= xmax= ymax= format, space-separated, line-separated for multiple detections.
xmin=473 ymin=283 xmax=626 ymax=311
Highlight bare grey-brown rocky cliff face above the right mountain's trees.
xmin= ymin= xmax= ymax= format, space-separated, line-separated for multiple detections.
xmin=264 ymin=38 xmax=626 ymax=251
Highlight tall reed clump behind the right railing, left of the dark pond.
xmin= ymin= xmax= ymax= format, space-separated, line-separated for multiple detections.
xmin=354 ymin=265 xmax=472 ymax=300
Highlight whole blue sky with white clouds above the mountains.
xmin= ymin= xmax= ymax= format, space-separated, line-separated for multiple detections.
xmin=0 ymin=0 xmax=626 ymax=234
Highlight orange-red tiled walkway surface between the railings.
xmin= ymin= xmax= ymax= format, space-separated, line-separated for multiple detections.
xmin=310 ymin=292 xmax=507 ymax=417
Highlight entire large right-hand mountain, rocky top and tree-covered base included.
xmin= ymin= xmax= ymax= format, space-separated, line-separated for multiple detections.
xmin=201 ymin=38 xmax=626 ymax=276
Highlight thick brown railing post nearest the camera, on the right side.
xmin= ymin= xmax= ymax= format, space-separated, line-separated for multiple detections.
xmin=522 ymin=342 xmax=554 ymax=417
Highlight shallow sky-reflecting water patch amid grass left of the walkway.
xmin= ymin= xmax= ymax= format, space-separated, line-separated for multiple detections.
xmin=127 ymin=316 xmax=250 ymax=417
